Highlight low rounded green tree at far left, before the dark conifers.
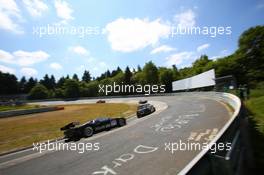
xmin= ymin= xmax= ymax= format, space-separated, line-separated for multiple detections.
xmin=28 ymin=84 xmax=49 ymax=99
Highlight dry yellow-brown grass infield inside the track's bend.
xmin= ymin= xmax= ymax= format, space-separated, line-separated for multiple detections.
xmin=0 ymin=103 xmax=137 ymax=153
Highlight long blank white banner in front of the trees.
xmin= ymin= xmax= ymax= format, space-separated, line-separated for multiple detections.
xmin=172 ymin=69 xmax=215 ymax=91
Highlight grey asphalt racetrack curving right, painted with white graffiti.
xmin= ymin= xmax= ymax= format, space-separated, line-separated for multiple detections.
xmin=0 ymin=96 xmax=230 ymax=175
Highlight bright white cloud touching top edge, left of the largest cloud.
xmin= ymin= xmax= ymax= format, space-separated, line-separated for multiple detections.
xmin=55 ymin=0 xmax=74 ymax=22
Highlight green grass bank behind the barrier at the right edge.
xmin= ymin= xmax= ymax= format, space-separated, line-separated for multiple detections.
xmin=245 ymin=89 xmax=264 ymax=169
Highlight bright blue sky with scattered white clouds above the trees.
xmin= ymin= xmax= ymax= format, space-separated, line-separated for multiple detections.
xmin=0 ymin=0 xmax=264 ymax=79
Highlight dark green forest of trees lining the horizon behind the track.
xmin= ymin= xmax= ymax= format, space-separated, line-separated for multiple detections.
xmin=0 ymin=26 xmax=264 ymax=99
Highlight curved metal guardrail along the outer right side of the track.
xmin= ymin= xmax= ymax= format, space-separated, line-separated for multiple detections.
xmin=179 ymin=92 xmax=253 ymax=175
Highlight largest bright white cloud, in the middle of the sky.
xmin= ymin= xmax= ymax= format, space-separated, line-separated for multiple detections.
xmin=104 ymin=18 xmax=170 ymax=52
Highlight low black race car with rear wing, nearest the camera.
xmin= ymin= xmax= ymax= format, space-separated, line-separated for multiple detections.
xmin=61 ymin=118 xmax=126 ymax=141
